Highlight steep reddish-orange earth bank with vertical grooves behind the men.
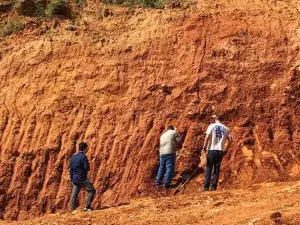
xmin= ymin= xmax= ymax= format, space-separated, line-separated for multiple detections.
xmin=0 ymin=0 xmax=300 ymax=220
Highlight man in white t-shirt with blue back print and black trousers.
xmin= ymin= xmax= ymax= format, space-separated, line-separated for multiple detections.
xmin=202 ymin=115 xmax=232 ymax=191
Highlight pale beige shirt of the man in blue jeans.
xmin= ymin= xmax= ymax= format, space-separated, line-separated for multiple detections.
xmin=159 ymin=130 xmax=179 ymax=155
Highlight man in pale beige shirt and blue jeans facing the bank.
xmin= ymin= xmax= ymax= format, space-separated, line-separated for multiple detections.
xmin=155 ymin=125 xmax=180 ymax=188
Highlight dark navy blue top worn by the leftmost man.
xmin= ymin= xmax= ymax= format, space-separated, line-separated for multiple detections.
xmin=70 ymin=152 xmax=90 ymax=184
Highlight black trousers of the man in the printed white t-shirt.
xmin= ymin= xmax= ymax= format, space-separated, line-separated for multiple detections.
xmin=204 ymin=150 xmax=224 ymax=190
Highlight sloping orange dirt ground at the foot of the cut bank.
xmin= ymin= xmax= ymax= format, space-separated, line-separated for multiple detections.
xmin=0 ymin=182 xmax=300 ymax=225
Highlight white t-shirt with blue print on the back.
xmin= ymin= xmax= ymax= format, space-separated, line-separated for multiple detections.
xmin=206 ymin=122 xmax=231 ymax=151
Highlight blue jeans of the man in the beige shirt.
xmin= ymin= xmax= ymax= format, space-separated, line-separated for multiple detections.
xmin=155 ymin=153 xmax=176 ymax=185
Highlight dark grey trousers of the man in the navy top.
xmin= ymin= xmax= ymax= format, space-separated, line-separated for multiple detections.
xmin=71 ymin=179 xmax=96 ymax=210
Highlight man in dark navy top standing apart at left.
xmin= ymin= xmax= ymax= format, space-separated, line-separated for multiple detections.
xmin=70 ymin=142 xmax=96 ymax=211
